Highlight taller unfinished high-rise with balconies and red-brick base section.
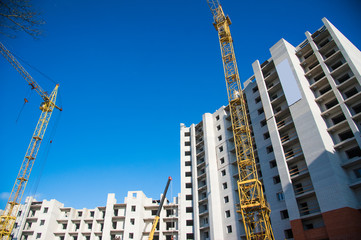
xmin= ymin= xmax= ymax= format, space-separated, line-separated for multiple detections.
xmin=179 ymin=19 xmax=361 ymax=240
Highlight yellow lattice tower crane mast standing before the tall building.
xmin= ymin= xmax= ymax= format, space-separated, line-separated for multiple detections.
xmin=207 ymin=0 xmax=274 ymax=240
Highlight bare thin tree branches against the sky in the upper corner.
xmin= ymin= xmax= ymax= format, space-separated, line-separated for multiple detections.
xmin=0 ymin=0 xmax=45 ymax=38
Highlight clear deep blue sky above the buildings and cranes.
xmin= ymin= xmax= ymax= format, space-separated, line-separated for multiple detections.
xmin=0 ymin=0 xmax=361 ymax=209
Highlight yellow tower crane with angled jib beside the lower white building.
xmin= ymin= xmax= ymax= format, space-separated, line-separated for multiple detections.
xmin=0 ymin=43 xmax=62 ymax=240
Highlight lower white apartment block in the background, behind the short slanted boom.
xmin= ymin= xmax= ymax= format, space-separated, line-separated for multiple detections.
xmin=13 ymin=191 xmax=178 ymax=240
